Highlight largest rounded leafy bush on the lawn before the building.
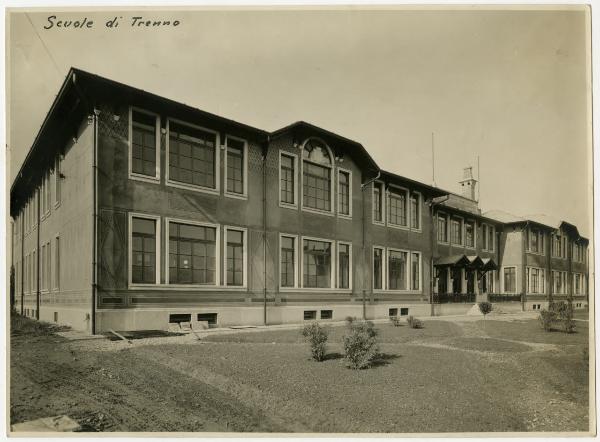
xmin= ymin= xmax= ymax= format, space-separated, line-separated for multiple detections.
xmin=343 ymin=320 xmax=379 ymax=370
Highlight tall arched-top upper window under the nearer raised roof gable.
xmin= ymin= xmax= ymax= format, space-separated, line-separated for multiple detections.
xmin=302 ymin=139 xmax=332 ymax=212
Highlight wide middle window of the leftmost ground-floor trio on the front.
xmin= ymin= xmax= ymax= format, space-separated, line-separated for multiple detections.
xmin=169 ymin=221 xmax=216 ymax=285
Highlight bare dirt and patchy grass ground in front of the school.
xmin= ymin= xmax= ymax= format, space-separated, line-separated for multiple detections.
xmin=10 ymin=312 xmax=588 ymax=433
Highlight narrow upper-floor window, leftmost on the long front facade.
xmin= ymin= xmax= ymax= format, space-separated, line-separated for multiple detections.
xmin=131 ymin=109 xmax=158 ymax=178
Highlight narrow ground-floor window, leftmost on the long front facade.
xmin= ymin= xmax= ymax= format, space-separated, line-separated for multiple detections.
xmin=131 ymin=217 xmax=158 ymax=284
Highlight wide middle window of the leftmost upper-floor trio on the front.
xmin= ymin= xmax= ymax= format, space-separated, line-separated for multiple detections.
xmin=169 ymin=120 xmax=217 ymax=189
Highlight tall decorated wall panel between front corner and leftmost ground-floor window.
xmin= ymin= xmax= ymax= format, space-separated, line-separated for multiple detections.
xmin=98 ymin=210 xmax=127 ymax=289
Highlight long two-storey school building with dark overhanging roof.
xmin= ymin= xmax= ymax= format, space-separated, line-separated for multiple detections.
xmin=11 ymin=69 xmax=588 ymax=333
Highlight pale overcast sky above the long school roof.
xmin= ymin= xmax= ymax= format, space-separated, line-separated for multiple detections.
xmin=7 ymin=9 xmax=591 ymax=235
